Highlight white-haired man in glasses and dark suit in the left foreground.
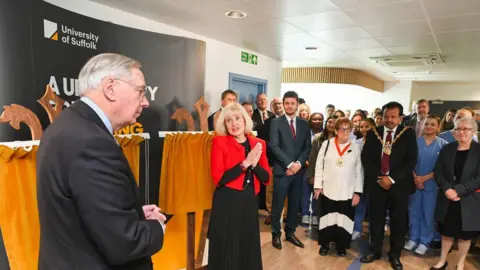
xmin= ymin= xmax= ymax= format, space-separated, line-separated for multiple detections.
xmin=37 ymin=54 xmax=165 ymax=270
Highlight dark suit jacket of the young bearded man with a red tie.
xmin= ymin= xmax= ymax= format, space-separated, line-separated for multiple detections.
xmin=270 ymin=115 xmax=312 ymax=175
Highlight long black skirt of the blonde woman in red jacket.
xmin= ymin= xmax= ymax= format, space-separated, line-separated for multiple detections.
xmin=208 ymin=185 xmax=262 ymax=270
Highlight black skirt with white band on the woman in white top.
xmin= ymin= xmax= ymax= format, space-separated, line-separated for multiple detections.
xmin=318 ymin=195 xmax=355 ymax=248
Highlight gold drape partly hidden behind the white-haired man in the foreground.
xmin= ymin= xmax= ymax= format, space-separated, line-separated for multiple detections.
xmin=0 ymin=136 xmax=143 ymax=270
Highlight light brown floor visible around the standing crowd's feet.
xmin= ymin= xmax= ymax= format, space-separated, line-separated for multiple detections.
xmin=260 ymin=211 xmax=480 ymax=270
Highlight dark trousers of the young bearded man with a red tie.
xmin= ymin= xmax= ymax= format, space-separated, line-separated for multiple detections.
xmin=272 ymin=170 xmax=303 ymax=237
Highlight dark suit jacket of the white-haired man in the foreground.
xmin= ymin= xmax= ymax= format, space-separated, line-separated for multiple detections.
xmin=37 ymin=101 xmax=163 ymax=270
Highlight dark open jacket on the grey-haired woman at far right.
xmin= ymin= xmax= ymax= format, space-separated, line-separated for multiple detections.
xmin=434 ymin=141 xmax=480 ymax=231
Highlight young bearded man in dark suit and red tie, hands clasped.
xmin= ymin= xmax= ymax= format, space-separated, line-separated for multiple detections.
xmin=270 ymin=91 xmax=311 ymax=249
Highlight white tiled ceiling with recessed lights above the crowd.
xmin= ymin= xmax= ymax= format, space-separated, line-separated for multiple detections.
xmin=91 ymin=0 xmax=480 ymax=81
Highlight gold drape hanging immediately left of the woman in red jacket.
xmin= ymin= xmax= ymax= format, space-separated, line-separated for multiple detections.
xmin=153 ymin=132 xmax=215 ymax=269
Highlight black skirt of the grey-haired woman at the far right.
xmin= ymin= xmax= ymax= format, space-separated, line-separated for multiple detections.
xmin=438 ymin=201 xmax=478 ymax=240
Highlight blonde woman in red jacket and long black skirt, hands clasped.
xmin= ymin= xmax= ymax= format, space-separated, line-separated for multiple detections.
xmin=208 ymin=103 xmax=271 ymax=270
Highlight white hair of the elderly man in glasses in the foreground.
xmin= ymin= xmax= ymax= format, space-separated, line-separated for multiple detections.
xmin=78 ymin=53 xmax=142 ymax=96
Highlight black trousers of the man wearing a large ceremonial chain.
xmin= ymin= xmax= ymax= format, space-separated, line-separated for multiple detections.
xmin=368 ymin=183 xmax=409 ymax=258
